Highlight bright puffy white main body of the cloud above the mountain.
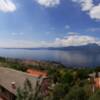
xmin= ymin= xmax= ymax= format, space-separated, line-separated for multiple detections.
xmin=52 ymin=35 xmax=97 ymax=46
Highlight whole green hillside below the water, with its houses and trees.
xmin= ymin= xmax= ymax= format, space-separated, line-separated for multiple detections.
xmin=0 ymin=58 xmax=100 ymax=100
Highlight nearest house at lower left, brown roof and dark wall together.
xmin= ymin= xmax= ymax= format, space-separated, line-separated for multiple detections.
xmin=0 ymin=67 xmax=48 ymax=100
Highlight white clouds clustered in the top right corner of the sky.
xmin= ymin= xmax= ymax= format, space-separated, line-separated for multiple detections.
xmin=72 ymin=0 xmax=100 ymax=20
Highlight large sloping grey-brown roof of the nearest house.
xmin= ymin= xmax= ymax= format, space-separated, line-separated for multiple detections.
xmin=0 ymin=67 xmax=43 ymax=95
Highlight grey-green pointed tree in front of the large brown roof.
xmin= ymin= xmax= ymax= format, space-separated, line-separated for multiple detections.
xmin=16 ymin=79 xmax=42 ymax=100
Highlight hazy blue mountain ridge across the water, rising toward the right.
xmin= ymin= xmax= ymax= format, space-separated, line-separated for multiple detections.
xmin=31 ymin=43 xmax=100 ymax=53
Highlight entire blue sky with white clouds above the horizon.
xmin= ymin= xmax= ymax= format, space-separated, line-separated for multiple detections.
xmin=0 ymin=0 xmax=100 ymax=48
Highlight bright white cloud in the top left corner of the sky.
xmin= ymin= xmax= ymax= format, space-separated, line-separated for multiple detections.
xmin=0 ymin=0 xmax=16 ymax=13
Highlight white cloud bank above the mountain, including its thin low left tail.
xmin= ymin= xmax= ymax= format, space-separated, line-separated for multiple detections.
xmin=42 ymin=32 xmax=100 ymax=47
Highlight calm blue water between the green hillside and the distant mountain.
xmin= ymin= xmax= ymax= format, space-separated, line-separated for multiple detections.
xmin=0 ymin=49 xmax=100 ymax=67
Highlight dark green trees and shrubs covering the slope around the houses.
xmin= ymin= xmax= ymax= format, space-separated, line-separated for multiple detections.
xmin=0 ymin=57 xmax=100 ymax=100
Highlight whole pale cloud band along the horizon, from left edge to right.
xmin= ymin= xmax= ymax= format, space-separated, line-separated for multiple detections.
xmin=0 ymin=32 xmax=100 ymax=48
